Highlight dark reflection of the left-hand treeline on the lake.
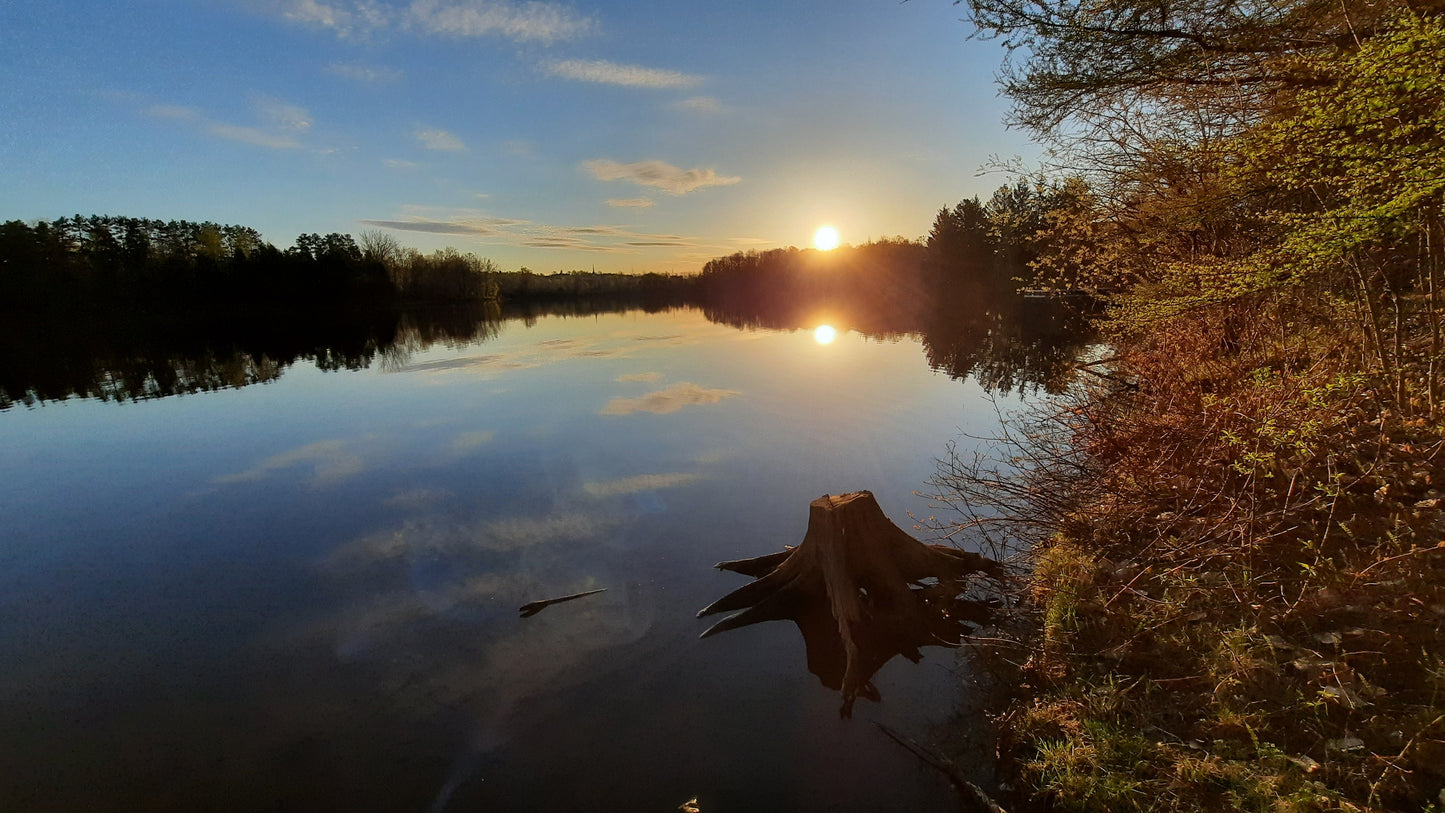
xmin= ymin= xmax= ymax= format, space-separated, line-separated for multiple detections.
xmin=0 ymin=299 xmax=684 ymax=410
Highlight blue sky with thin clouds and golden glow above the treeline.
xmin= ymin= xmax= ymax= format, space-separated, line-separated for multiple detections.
xmin=0 ymin=0 xmax=1039 ymax=273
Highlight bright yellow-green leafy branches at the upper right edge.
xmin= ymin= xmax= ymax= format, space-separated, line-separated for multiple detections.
xmin=1241 ymin=13 xmax=1445 ymax=277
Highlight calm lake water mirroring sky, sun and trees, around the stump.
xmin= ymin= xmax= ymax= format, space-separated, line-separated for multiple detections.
xmin=0 ymin=300 xmax=1072 ymax=812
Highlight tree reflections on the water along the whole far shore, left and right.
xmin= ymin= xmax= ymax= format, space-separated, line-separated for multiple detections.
xmin=0 ymin=289 xmax=1084 ymax=410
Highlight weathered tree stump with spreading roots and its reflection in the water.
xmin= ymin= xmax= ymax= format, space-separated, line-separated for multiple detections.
xmin=698 ymin=491 xmax=1006 ymax=718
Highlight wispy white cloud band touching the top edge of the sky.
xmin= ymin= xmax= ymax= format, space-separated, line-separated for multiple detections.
xmin=266 ymin=0 xmax=597 ymax=43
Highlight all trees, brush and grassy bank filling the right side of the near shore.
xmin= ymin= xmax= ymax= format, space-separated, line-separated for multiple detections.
xmin=935 ymin=0 xmax=1445 ymax=812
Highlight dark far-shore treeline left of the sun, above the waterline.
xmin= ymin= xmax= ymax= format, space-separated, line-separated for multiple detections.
xmin=0 ymin=215 xmax=692 ymax=312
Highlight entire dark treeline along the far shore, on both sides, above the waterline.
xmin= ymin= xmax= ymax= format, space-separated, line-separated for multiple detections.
xmin=0 ymin=189 xmax=1066 ymax=318
